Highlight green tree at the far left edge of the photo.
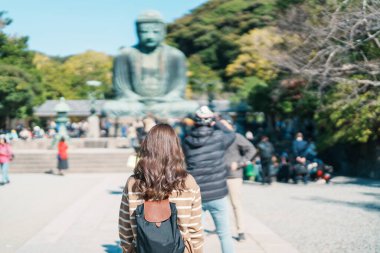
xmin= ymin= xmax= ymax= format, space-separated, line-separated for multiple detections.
xmin=0 ymin=12 xmax=44 ymax=127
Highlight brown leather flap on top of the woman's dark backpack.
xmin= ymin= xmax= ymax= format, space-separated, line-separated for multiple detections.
xmin=144 ymin=199 xmax=172 ymax=227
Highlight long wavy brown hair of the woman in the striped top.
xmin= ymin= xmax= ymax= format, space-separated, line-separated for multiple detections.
xmin=134 ymin=124 xmax=188 ymax=200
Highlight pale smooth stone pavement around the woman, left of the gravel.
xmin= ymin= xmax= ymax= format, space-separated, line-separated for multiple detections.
xmin=0 ymin=173 xmax=297 ymax=253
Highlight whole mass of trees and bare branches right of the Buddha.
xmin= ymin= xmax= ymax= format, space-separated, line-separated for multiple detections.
xmin=168 ymin=0 xmax=380 ymax=147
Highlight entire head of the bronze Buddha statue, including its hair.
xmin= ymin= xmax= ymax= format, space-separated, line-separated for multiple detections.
xmin=136 ymin=11 xmax=166 ymax=49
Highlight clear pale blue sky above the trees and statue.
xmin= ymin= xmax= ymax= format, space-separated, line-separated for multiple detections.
xmin=0 ymin=0 xmax=206 ymax=56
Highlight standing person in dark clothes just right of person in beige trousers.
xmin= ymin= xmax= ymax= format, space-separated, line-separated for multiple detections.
xmin=257 ymin=135 xmax=275 ymax=184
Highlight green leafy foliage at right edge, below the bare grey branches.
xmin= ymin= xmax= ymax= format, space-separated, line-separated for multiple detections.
xmin=316 ymin=83 xmax=380 ymax=146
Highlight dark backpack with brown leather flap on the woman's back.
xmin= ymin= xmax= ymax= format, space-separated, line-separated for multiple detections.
xmin=136 ymin=199 xmax=185 ymax=253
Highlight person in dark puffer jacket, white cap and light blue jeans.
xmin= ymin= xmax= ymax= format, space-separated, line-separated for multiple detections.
xmin=183 ymin=106 xmax=235 ymax=253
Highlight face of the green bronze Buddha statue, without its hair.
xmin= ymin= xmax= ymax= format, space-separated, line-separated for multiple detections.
xmin=137 ymin=22 xmax=165 ymax=48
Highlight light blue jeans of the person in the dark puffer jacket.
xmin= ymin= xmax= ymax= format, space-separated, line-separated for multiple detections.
xmin=202 ymin=197 xmax=235 ymax=253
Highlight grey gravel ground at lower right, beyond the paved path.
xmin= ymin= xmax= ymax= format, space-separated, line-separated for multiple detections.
xmin=242 ymin=176 xmax=380 ymax=253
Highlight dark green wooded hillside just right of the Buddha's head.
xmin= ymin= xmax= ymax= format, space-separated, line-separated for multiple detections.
xmin=167 ymin=0 xmax=275 ymax=87
